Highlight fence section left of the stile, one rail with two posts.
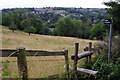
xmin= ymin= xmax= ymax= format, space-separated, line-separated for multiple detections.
xmin=0 ymin=47 xmax=69 ymax=80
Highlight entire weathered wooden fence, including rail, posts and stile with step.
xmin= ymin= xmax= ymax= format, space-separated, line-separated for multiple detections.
xmin=0 ymin=42 xmax=99 ymax=80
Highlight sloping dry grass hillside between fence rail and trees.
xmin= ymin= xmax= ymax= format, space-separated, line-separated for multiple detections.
xmin=2 ymin=27 xmax=96 ymax=53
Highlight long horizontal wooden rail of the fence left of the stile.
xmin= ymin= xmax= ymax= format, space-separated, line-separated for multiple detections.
xmin=0 ymin=49 xmax=65 ymax=57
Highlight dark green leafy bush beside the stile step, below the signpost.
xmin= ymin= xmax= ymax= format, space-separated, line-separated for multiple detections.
xmin=92 ymin=54 xmax=120 ymax=80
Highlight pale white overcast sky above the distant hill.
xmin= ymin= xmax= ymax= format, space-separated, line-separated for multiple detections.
xmin=0 ymin=0 xmax=110 ymax=9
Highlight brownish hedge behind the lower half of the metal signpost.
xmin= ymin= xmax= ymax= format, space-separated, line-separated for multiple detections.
xmin=95 ymin=35 xmax=120 ymax=61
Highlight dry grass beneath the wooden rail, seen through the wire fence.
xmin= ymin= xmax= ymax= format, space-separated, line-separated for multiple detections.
xmin=0 ymin=55 xmax=65 ymax=78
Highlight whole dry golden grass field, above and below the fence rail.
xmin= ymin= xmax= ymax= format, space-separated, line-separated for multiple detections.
xmin=2 ymin=27 xmax=97 ymax=78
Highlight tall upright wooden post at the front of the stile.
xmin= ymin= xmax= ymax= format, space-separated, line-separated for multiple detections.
xmin=74 ymin=43 xmax=79 ymax=78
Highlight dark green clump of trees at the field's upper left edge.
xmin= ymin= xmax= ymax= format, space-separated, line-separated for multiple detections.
xmin=2 ymin=9 xmax=47 ymax=34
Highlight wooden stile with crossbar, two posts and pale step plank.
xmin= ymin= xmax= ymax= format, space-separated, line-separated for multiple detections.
xmin=69 ymin=42 xmax=98 ymax=77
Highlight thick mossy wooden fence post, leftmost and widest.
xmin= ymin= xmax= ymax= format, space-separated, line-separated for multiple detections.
xmin=17 ymin=47 xmax=28 ymax=80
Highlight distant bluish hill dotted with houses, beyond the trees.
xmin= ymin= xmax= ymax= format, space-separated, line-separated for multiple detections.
xmin=2 ymin=7 xmax=107 ymax=27
